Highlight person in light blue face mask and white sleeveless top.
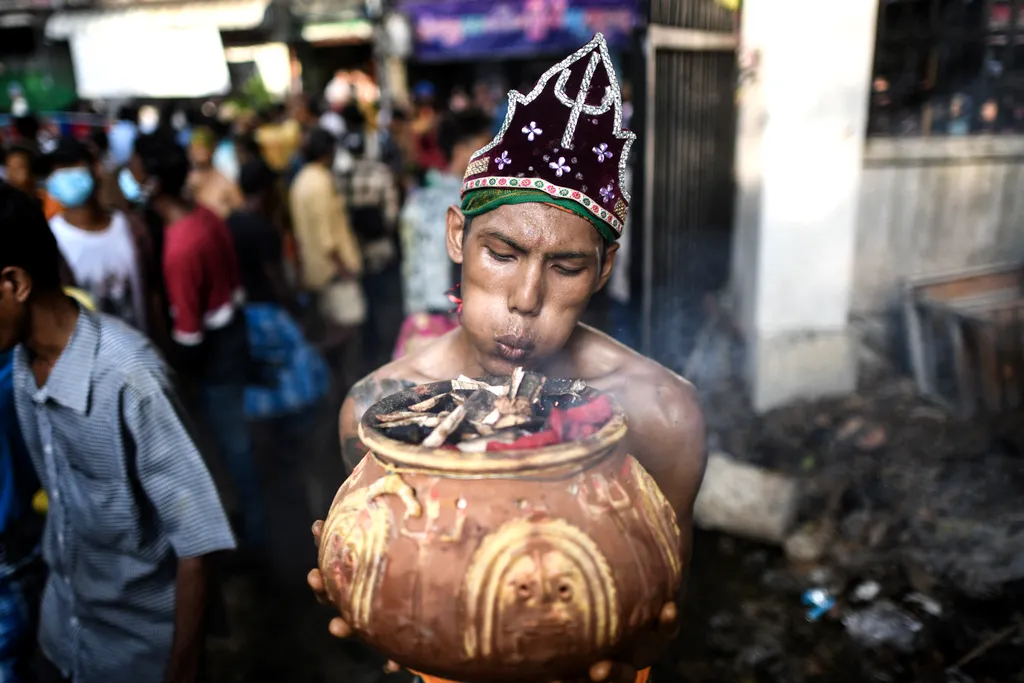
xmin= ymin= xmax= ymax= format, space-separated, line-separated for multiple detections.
xmin=46 ymin=138 xmax=159 ymax=332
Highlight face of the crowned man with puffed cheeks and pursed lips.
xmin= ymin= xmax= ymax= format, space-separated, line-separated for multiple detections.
xmin=447 ymin=203 xmax=617 ymax=375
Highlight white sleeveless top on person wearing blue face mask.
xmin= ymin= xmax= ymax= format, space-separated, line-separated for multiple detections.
xmin=50 ymin=211 xmax=146 ymax=332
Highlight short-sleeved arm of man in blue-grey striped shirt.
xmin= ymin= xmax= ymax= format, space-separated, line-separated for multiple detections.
xmin=122 ymin=373 xmax=234 ymax=683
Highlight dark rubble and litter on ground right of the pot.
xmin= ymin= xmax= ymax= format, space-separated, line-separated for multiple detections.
xmin=671 ymin=375 xmax=1024 ymax=683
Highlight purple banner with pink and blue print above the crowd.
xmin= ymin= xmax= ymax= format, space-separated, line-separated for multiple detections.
xmin=398 ymin=0 xmax=638 ymax=61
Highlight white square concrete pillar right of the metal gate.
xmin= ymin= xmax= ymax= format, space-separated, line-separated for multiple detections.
xmin=732 ymin=0 xmax=878 ymax=411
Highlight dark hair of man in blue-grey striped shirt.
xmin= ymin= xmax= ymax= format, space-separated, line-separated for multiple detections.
xmin=0 ymin=181 xmax=60 ymax=292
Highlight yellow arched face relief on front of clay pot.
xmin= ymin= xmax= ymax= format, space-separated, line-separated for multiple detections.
xmin=465 ymin=519 xmax=618 ymax=664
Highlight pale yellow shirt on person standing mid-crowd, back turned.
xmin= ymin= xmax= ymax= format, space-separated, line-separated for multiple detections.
xmin=289 ymin=164 xmax=362 ymax=291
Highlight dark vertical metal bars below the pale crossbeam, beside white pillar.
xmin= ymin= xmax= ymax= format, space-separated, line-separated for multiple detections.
xmin=642 ymin=50 xmax=736 ymax=370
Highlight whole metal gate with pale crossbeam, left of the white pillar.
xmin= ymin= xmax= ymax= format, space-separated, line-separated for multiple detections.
xmin=634 ymin=0 xmax=737 ymax=370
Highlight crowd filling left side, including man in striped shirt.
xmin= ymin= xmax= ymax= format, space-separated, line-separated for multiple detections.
xmin=0 ymin=81 xmax=507 ymax=683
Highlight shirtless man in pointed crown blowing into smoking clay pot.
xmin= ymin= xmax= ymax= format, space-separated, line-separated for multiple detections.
xmin=309 ymin=37 xmax=706 ymax=682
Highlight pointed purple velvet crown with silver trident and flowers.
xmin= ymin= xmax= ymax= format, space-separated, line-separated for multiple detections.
xmin=462 ymin=34 xmax=635 ymax=237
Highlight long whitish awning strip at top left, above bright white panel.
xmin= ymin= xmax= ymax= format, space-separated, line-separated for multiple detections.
xmin=46 ymin=0 xmax=270 ymax=40
